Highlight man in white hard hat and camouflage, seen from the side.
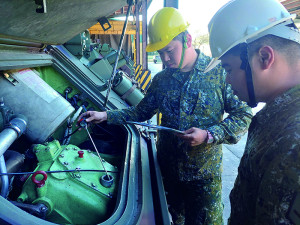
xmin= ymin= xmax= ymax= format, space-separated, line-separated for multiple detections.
xmin=206 ymin=0 xmax=300 ymax=225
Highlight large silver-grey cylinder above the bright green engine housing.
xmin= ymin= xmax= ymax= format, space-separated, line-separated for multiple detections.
xmin=0 ymin=69 xmax=74 ymax=143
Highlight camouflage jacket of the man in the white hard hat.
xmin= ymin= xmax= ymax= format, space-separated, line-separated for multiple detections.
xmin=229 ymin=85 xmax=300 ymax=225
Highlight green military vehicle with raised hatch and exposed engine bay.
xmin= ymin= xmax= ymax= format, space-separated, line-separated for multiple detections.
xmin=0 ymin=0 xmax=164 ymax=225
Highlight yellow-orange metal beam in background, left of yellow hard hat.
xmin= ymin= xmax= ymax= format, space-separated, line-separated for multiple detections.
xmin=88 ymin=20 xmax=142 ymax=35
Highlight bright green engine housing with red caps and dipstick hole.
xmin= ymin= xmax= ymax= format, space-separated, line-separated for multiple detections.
xmin=17 ymin=141 xmax=118 ymax=224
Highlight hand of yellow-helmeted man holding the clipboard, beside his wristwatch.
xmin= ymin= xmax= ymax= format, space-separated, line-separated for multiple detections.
xmin=178 ymin=127 xmax=207 ymax=146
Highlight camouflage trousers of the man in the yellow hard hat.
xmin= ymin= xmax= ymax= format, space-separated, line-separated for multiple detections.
xmin=164 ymin=176 xmax=223 ymax=225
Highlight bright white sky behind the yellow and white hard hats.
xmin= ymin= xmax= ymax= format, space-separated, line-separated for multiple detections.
xmin=147 ymin=0 xmax=229 ymax=36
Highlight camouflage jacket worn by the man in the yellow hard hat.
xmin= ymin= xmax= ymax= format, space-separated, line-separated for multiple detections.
xmin=107 ymin=50 xmax=252 ymax=180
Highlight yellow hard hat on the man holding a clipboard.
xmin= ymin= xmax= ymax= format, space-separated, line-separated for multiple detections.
xmin=146 ymin=7 xmax=189 ymax=52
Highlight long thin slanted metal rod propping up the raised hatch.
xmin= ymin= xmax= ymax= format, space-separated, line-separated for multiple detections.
xmin=104 ymin=0 xmax=133 ymax=108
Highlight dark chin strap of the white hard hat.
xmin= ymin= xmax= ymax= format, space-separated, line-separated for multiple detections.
xmin=240 ymin=43 xmax=257 ymax=108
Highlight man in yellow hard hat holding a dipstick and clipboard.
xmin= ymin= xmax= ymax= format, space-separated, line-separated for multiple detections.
xmin=83 ymin=7 xmax=252 ymax=224
